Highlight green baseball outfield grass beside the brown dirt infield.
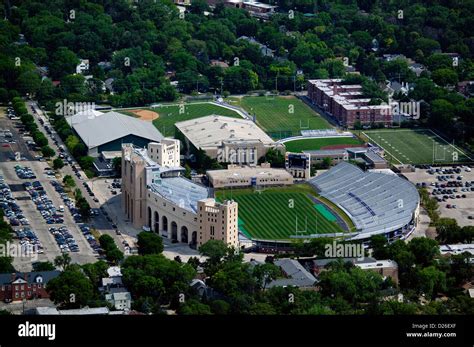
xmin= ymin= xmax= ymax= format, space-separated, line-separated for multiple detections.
xmin=121 ymin=103 xmax=241 ymax=136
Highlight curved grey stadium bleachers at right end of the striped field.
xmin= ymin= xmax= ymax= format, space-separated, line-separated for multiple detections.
xmin=309 ymin=162 xmax=420 ymax=239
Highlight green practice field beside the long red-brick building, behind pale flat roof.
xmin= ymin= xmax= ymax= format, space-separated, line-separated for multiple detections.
xmin=233 ymin=96 xmax=333 ymax=139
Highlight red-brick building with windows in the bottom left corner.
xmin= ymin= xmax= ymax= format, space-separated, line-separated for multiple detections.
xmin=0 ymin=271 xmax=61 ymax=302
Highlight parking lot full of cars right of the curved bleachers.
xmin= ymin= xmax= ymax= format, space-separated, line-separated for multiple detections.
xmin=404 ymin=165 xmax=474 ymax=226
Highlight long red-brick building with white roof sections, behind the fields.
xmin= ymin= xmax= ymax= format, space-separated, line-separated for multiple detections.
xmin=308 ymin=79 xmax=393 ymax=128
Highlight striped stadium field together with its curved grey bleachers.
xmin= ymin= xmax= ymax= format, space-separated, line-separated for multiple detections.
xmin=215 ymin=162 xmax=420 ymax=252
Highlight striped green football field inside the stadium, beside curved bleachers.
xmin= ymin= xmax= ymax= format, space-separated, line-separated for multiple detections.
xmin=216 ymin=185 xmax=343 ymax=240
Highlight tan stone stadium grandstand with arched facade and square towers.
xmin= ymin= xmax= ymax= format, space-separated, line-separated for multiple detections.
xmin=122 ymin=140 xmax=239 ymax=247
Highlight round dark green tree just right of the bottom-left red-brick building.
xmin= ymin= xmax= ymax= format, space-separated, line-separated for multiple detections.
xmin=46 ymin=266 xmax=94 ymax=308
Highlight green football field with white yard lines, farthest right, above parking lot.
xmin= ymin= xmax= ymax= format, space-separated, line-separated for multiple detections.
xmin=363 ymin=129 xmax=470 ymax=164
